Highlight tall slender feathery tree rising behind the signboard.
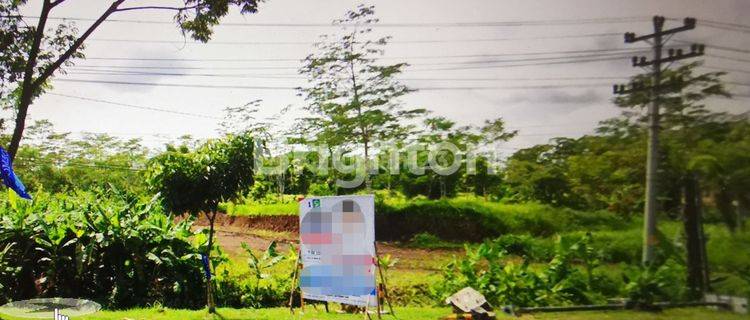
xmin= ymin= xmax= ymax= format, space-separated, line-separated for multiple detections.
xmin=298 ymin=5 xmax=424 ymax=188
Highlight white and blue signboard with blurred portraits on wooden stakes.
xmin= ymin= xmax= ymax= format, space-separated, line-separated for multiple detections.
xmin=299 ymin=195 xmax=378 ymax=306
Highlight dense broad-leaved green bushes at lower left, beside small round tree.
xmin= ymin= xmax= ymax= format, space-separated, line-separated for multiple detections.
xmin=0 ymin=190 xmax=203 ymax=308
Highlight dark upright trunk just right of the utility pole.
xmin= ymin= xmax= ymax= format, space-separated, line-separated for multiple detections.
xmin=683 ymin=174 xmax=707 ymax=299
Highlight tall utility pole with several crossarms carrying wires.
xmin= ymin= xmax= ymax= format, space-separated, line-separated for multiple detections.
xmin=614 ymin=16 xmax=704 ymax=265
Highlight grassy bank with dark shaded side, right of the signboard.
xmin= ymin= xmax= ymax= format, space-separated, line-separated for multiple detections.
xmin=375 ymin=197 xmax=628 ymax=242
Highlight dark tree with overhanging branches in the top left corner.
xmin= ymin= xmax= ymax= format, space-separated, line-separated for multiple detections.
xmin=0 ymin=0 xmax=259 ymax=159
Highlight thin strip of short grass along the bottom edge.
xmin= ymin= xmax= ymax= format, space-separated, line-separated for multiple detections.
xmin=0 ymin=306 xmax=750 ymax=320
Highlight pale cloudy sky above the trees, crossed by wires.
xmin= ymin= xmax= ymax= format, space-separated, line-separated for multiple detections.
xmin=14 ymin=0 xmax=750 ymax=153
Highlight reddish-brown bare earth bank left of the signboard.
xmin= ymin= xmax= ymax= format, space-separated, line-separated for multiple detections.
xmin=184 ymin=212 xmax=299 ymax=233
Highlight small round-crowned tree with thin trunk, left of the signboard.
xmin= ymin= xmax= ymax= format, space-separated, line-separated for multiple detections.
xmin=147 ymin=135 xmax=254 ymax=312
